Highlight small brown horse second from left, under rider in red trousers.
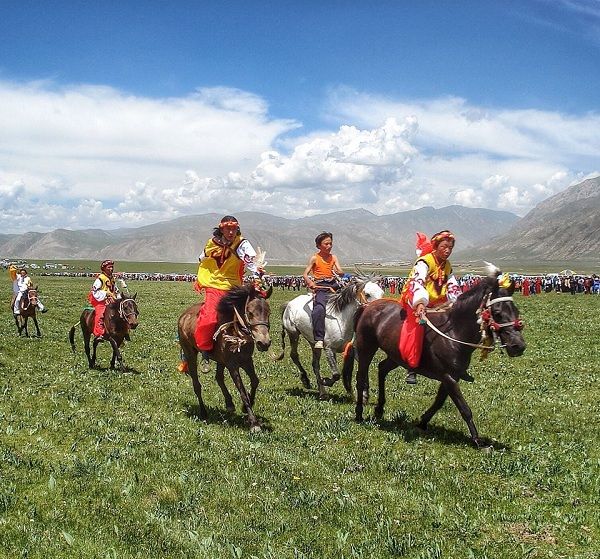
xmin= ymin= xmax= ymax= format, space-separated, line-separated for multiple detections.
xmin=69 ymin=293 xmax=140 ymax=371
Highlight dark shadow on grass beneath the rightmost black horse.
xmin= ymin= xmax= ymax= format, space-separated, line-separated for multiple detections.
xmin=376 ymin=412 xmax=512 ymax=452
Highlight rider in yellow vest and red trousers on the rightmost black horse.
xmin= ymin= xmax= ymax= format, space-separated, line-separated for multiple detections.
xmin=400 ymin=230 xmax=461 ymax=384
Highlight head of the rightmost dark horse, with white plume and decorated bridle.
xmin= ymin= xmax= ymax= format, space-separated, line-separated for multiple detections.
xmin=481 ymin=264 xmax=527 ymax=357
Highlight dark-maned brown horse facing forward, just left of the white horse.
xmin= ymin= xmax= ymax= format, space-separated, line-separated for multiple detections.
xmin=177 ymin=285 xmax=273 ymax=433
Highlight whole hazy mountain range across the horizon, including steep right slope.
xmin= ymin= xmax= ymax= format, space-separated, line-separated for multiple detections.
xmin=0 ymin=177 xmax=600 ymax=265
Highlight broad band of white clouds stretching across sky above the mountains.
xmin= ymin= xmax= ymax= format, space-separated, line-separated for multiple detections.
xmin=0 ymin=82 xmax=600 ymax=233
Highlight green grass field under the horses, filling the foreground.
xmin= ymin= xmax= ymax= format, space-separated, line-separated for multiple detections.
xmin=0 ymin=278 xmax=600 ymax=559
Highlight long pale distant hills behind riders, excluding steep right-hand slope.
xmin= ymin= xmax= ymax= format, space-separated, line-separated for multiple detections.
xmin=0 ymin=206 xmax=519 ymax=265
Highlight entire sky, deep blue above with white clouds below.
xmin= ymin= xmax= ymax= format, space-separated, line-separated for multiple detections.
xmin=0 ymin=0 xmax=600 ymax=233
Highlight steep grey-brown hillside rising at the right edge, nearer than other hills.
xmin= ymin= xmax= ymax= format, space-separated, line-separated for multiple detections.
xmin=457 ymin=177 xmax=600 ymax=261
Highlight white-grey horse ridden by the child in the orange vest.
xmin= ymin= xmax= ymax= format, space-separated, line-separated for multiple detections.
xmin=275 ymin=276 xmax=383 ymax=399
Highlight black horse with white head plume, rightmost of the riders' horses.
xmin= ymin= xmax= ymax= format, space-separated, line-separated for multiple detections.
xmin=342 ymin=266 xmax=526 ymax=447
